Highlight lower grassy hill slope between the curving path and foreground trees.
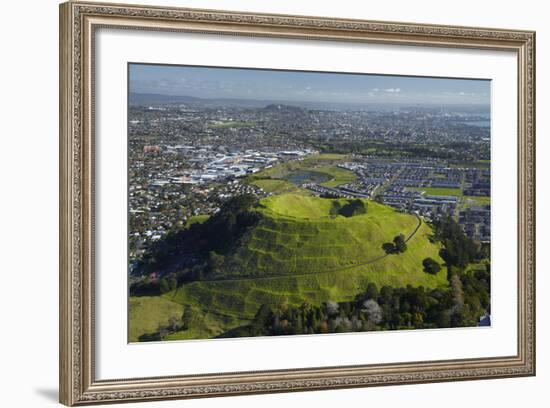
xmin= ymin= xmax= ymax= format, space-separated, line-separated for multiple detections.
xmin=165 ymin=220 xmax=447 ymax=318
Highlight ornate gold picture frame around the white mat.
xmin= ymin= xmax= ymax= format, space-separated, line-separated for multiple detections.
xmin=59 ymin=2 xmax=535 ymax=406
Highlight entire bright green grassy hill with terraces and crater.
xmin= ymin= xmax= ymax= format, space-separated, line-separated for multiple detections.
xmin=130 ymin=194 xmax=447 ymax=339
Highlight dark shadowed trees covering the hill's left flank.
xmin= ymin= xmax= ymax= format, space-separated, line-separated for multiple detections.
xmin=130 ymin=194 xmax=261 ymax=295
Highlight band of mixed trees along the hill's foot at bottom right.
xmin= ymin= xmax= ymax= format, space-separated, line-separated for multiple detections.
xmin=226 ymin=267 xmax=490 ymax=337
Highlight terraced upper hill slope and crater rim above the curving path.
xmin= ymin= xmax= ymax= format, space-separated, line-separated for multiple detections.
xmin=219 ymin=194 xmax=439 ymax=283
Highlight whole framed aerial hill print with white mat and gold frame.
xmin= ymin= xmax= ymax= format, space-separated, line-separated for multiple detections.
xmin=60 ymin=2 xmax=535 ymax=405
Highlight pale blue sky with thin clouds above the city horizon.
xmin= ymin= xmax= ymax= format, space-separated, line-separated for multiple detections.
xmin=130 ymin=64 xmax=490 ymax=106
